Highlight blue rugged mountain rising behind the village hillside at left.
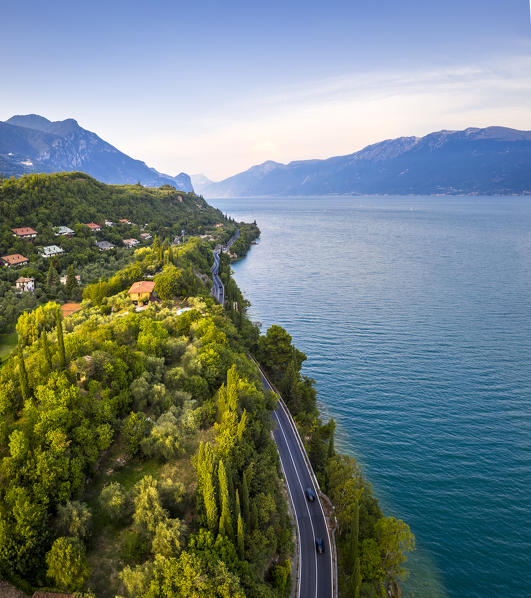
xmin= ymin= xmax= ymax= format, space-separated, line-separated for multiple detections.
xmin=0 ymin=114 xmax=193 ymax=191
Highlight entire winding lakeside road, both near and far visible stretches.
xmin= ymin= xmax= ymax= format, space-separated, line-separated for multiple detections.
xmin=211 ymin=239 xmax=335 ymax=598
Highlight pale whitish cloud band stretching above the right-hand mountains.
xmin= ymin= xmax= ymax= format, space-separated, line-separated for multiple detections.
xmin=118 ymin=57 xmax=531 ymax=179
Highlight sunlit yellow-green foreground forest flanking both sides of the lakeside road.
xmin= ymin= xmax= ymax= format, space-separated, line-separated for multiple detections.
xmin=0 ymin=184 xmax=414 ymax=598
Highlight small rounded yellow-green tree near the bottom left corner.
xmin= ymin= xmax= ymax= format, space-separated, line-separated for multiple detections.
xmin=46 ymin=537 xmax=89 ymax=592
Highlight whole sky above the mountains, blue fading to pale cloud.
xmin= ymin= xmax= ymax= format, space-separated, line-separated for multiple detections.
xmin=0 ymin=0 xmax=531 ymax=180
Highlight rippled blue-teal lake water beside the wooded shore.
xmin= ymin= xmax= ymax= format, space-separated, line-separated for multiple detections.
xmin=212 ymin=197 xmax=531 ymax=598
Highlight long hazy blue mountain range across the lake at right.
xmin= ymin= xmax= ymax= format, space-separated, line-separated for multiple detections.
xmin=200 ymin=127 xmax=531 ymax=197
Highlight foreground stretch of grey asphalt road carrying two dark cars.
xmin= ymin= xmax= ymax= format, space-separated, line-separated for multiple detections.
xmin=262 ymin=376 xmax=333 ymax=598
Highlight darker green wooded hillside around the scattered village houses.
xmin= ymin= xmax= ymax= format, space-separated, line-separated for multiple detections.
xmin=0 ymin=172 xmax=259 ymax=334
